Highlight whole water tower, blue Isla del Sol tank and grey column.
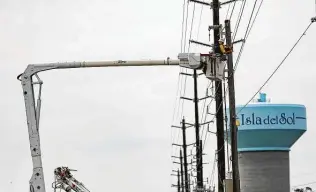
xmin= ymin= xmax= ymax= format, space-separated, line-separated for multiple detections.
xmin=227 ymin=93 xmax=306 ymax=192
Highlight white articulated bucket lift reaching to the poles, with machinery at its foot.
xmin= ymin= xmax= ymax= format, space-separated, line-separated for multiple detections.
xmin=17 ymin=53 xmax=225 ymax=192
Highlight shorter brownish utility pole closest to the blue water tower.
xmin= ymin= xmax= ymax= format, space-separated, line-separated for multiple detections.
xmin=225 ymin=20 xmax=240 ymax=192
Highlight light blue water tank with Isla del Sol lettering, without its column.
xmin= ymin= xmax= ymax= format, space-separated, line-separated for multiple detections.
xmin=227 ymin=103 xmax=307 ymax=152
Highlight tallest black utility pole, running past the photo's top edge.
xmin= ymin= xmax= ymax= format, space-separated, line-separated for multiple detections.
xmin=212 ymin=0 xmax=226 ymax=192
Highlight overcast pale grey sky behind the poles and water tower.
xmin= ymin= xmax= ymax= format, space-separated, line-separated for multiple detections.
xmin=0 ymin=0 xmax=316 ymax=192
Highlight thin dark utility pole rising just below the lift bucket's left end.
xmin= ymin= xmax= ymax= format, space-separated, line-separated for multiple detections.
xmin=193 ymin=70 xmax=203 ymax=189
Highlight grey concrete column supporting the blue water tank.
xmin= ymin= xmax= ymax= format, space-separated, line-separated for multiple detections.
xmin=239 ymin=151 xmax=290 ymax=192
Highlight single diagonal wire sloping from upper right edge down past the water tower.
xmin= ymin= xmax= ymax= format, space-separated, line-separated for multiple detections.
xmin=237 ymin=21 xmax=314 ymax=115
